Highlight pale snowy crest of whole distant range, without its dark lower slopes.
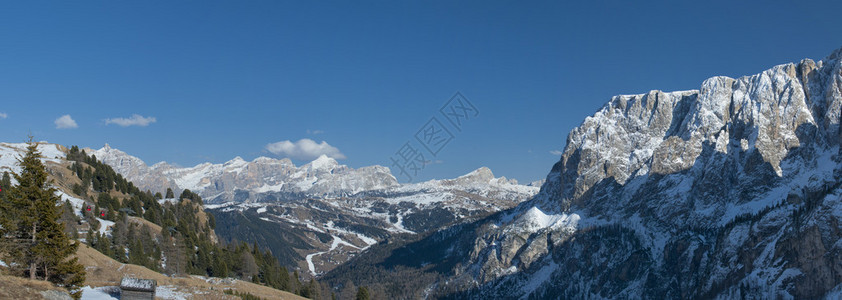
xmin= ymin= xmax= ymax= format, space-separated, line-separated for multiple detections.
xmin=85 ymin=144 xmax=539 ymax=204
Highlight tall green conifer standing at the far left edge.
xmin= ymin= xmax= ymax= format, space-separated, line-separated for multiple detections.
xmin=3 ymin=137 xmax=85 ymax=298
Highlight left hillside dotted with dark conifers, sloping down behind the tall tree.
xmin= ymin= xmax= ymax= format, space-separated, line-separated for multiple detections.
xmin=0 ymin=143 xmax=326 ymax=298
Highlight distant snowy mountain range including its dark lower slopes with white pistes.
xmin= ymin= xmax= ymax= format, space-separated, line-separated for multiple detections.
xmin=84 ymin=145 xmax=540 ymax=275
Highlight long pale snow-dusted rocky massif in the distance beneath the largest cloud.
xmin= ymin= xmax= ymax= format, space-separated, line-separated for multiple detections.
xmin=85 ymin=145 xmax=398 ymax=203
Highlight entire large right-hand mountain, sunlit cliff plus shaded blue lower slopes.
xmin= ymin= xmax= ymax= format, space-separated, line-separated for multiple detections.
xmin=328 ymin=49 xmax=842 ymax=299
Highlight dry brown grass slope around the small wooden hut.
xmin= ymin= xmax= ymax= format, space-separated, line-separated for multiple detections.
xmin=75 ymin=245 xmax=305 ymax=299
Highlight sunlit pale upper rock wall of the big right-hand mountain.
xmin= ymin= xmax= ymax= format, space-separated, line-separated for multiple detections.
xmin=548 ymin=56 xmax=828 ymax=209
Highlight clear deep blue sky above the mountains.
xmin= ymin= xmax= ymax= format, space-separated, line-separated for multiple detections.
xmin=0 ymin=1 xmax=842 ymax=181
